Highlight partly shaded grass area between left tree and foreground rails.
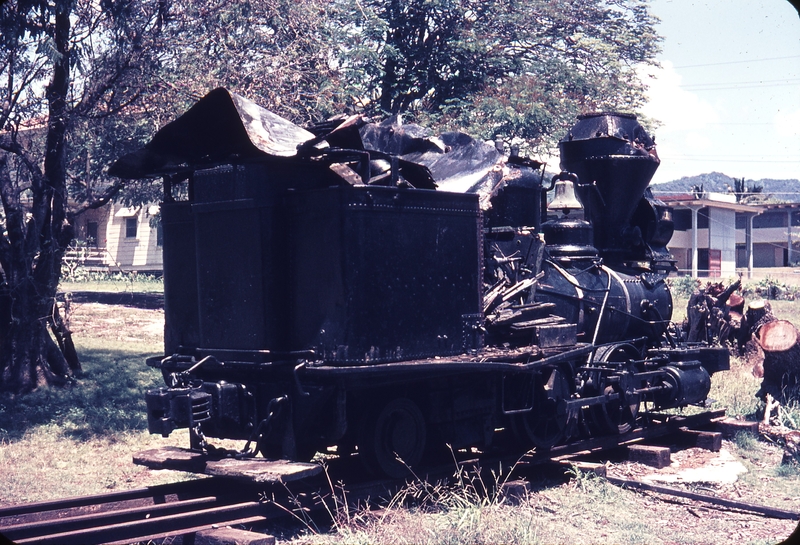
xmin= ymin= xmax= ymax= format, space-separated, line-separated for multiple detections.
xmin=0 ymin=338 xmax=188 ymax=504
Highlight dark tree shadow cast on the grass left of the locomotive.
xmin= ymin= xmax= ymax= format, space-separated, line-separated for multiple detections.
xmin=0 ymin=349 xmax=163 ymax=440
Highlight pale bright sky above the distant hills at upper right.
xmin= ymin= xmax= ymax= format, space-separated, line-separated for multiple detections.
xmin=642 ymin=0 xmax=800 ymax=183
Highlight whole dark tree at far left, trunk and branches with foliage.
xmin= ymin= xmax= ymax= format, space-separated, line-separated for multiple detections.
xmin=0 ymin=0 xmax=167 ymax=392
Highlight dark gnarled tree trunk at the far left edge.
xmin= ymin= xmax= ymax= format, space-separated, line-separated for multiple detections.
xmin=0 ymin=0 xmax=80 ymax=393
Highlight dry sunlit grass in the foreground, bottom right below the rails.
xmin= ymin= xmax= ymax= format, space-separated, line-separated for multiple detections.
xmin=294 ymin=464 xmax=797 ymax=545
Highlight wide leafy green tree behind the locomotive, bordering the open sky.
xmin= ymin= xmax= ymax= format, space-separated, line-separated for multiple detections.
xmin=339 ymin=0 xmax=660 ymax=153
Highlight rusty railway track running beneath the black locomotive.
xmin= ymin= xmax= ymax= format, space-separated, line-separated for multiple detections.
xmin=0 ymin=411 xmax=768 ymax=545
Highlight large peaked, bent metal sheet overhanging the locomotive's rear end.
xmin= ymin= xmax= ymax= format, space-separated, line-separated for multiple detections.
xmin=108 ymin=88 xmax=314 ymax=178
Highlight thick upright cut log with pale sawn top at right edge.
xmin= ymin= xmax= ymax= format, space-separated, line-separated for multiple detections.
xmin=756 ymin=320 xmax=800 ymax=400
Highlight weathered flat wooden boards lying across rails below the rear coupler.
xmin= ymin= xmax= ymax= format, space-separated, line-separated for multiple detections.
xmin=133 ymin=447 xmax=322 ymax=483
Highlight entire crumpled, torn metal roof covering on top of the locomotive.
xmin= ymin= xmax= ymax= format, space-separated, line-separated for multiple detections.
xmin=109 ymin=88 xmax=538 ymax=206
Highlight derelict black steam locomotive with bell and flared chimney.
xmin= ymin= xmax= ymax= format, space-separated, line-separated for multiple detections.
xmin=110 ymin=89 xmax=729 ymax=476
